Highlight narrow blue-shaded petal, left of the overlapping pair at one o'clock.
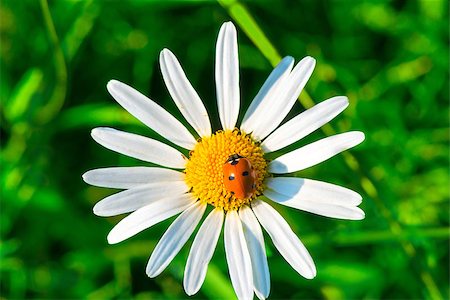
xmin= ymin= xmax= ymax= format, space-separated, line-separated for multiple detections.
xmin=241 ymin=56 xmax=294 ymax=133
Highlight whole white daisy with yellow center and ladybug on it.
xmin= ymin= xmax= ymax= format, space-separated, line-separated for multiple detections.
xmin=83 ymin=22 xmax=364 ymax=299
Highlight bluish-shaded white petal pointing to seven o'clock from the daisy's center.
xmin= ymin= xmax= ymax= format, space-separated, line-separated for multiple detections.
xmin=146 ymin=201 xmax=206 ymax=278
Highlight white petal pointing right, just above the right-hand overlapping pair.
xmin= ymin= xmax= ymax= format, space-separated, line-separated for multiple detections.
xmin=269 ymin=131 xmax=364 ymax=174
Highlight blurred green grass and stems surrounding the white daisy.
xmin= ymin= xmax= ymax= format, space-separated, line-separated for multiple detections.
xmin=0 ymin=0 xmax=449 ymax=299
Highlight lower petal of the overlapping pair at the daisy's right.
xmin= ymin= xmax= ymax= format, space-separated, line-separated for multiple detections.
xmin=264 ymin=189 xmax=365 ymax=220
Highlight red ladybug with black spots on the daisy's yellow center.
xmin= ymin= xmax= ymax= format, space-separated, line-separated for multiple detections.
xmin=223 ymin=154 xmax=256 ymax=199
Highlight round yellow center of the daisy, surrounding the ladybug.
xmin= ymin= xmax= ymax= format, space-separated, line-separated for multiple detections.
xmin=185 ymin=129 xmax=267 ymax=211
